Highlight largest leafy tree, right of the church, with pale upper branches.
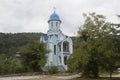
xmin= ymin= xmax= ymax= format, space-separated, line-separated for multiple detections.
xmin=68 ymin=13 xmax=120 ymax=77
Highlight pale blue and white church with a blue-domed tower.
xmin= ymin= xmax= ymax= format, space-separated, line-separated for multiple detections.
xmin=41 ymin=11 xmax=73 ymax=71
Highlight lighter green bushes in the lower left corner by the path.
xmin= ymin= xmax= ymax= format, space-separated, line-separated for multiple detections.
xmin=0 ymin=55 xmax=22 ymax=74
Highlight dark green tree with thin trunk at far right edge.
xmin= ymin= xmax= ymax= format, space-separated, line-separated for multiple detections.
xmin=98 ymin=35 xmax=120 ymax=77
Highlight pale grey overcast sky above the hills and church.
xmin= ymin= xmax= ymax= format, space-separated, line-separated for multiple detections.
xmin=0 ymin=0 xmax=120 ymax=36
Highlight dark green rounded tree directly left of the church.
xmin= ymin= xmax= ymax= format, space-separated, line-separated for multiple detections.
xmin=19 ymin=42 xmax=47 ymax=71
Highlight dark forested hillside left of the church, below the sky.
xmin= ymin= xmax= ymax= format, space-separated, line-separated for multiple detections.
xmin=0 ymin=33 xmax=42 ymax=56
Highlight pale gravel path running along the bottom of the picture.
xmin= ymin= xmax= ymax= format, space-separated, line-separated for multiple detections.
xmin=0 ymin=74 xmax=120 ymax=80
